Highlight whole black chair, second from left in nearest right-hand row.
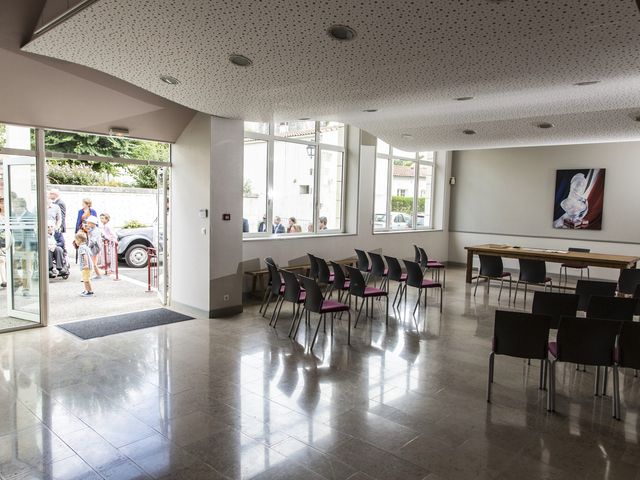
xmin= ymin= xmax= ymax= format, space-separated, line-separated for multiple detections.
xmin=547 ymin=317 xmax=622 ymax=417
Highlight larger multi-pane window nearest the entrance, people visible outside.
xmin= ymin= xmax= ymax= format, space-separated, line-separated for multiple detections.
xmin=243 ymin=120 xmax=345 ymax=237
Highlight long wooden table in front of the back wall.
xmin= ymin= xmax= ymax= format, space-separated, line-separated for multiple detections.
xmin=464 ymin=243 xmax=640 ymax=283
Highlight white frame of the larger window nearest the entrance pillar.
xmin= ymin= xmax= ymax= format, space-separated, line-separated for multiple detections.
xmin=242 ymin=121 xmax=348 ymax=240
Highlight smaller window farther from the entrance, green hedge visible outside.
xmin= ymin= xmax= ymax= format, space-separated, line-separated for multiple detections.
xmin=373 ymin=140 xmax=434 ymax=232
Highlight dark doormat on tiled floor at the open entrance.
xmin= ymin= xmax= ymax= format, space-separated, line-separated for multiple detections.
xmin=58 ymin=308 xmax=193 ymax=340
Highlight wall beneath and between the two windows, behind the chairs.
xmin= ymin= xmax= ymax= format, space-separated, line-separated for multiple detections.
xmin=243 ymin=132 xmax=450 ymax=289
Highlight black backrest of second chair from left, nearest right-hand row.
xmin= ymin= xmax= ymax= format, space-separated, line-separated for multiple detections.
xmin=556 ymin=317 xmax=622 ymax=366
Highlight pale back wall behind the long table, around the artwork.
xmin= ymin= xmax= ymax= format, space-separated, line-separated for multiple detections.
xmin=449 ymin=142 xmax=640 ymax=279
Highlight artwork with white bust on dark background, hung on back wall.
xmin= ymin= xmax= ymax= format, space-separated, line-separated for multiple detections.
xmin=553 ymin=168 xmax=605 ymax=230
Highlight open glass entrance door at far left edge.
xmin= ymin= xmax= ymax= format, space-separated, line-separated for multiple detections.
xmin=0 ymin=155 xmax=42 ymax=323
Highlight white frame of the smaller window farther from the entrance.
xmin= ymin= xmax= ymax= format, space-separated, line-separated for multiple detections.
xmin=371 ymin=139 xmax=438 ymax=235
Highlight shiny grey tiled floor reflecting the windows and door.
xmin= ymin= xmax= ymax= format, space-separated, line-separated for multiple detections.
xmin=0 ymin=269 xmax=640 ymax=480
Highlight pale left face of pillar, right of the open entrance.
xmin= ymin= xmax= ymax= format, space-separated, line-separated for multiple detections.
xmin=170 ymin=113 xmax=211 ymax=313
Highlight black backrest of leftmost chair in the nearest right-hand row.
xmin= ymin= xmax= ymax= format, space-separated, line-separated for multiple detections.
xmin=493 ymin=310 xmax=551 ymax=360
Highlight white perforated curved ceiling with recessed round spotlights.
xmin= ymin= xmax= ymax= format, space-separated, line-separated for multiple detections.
xmin=24 ymin=0 xmax=640 ymax=150
